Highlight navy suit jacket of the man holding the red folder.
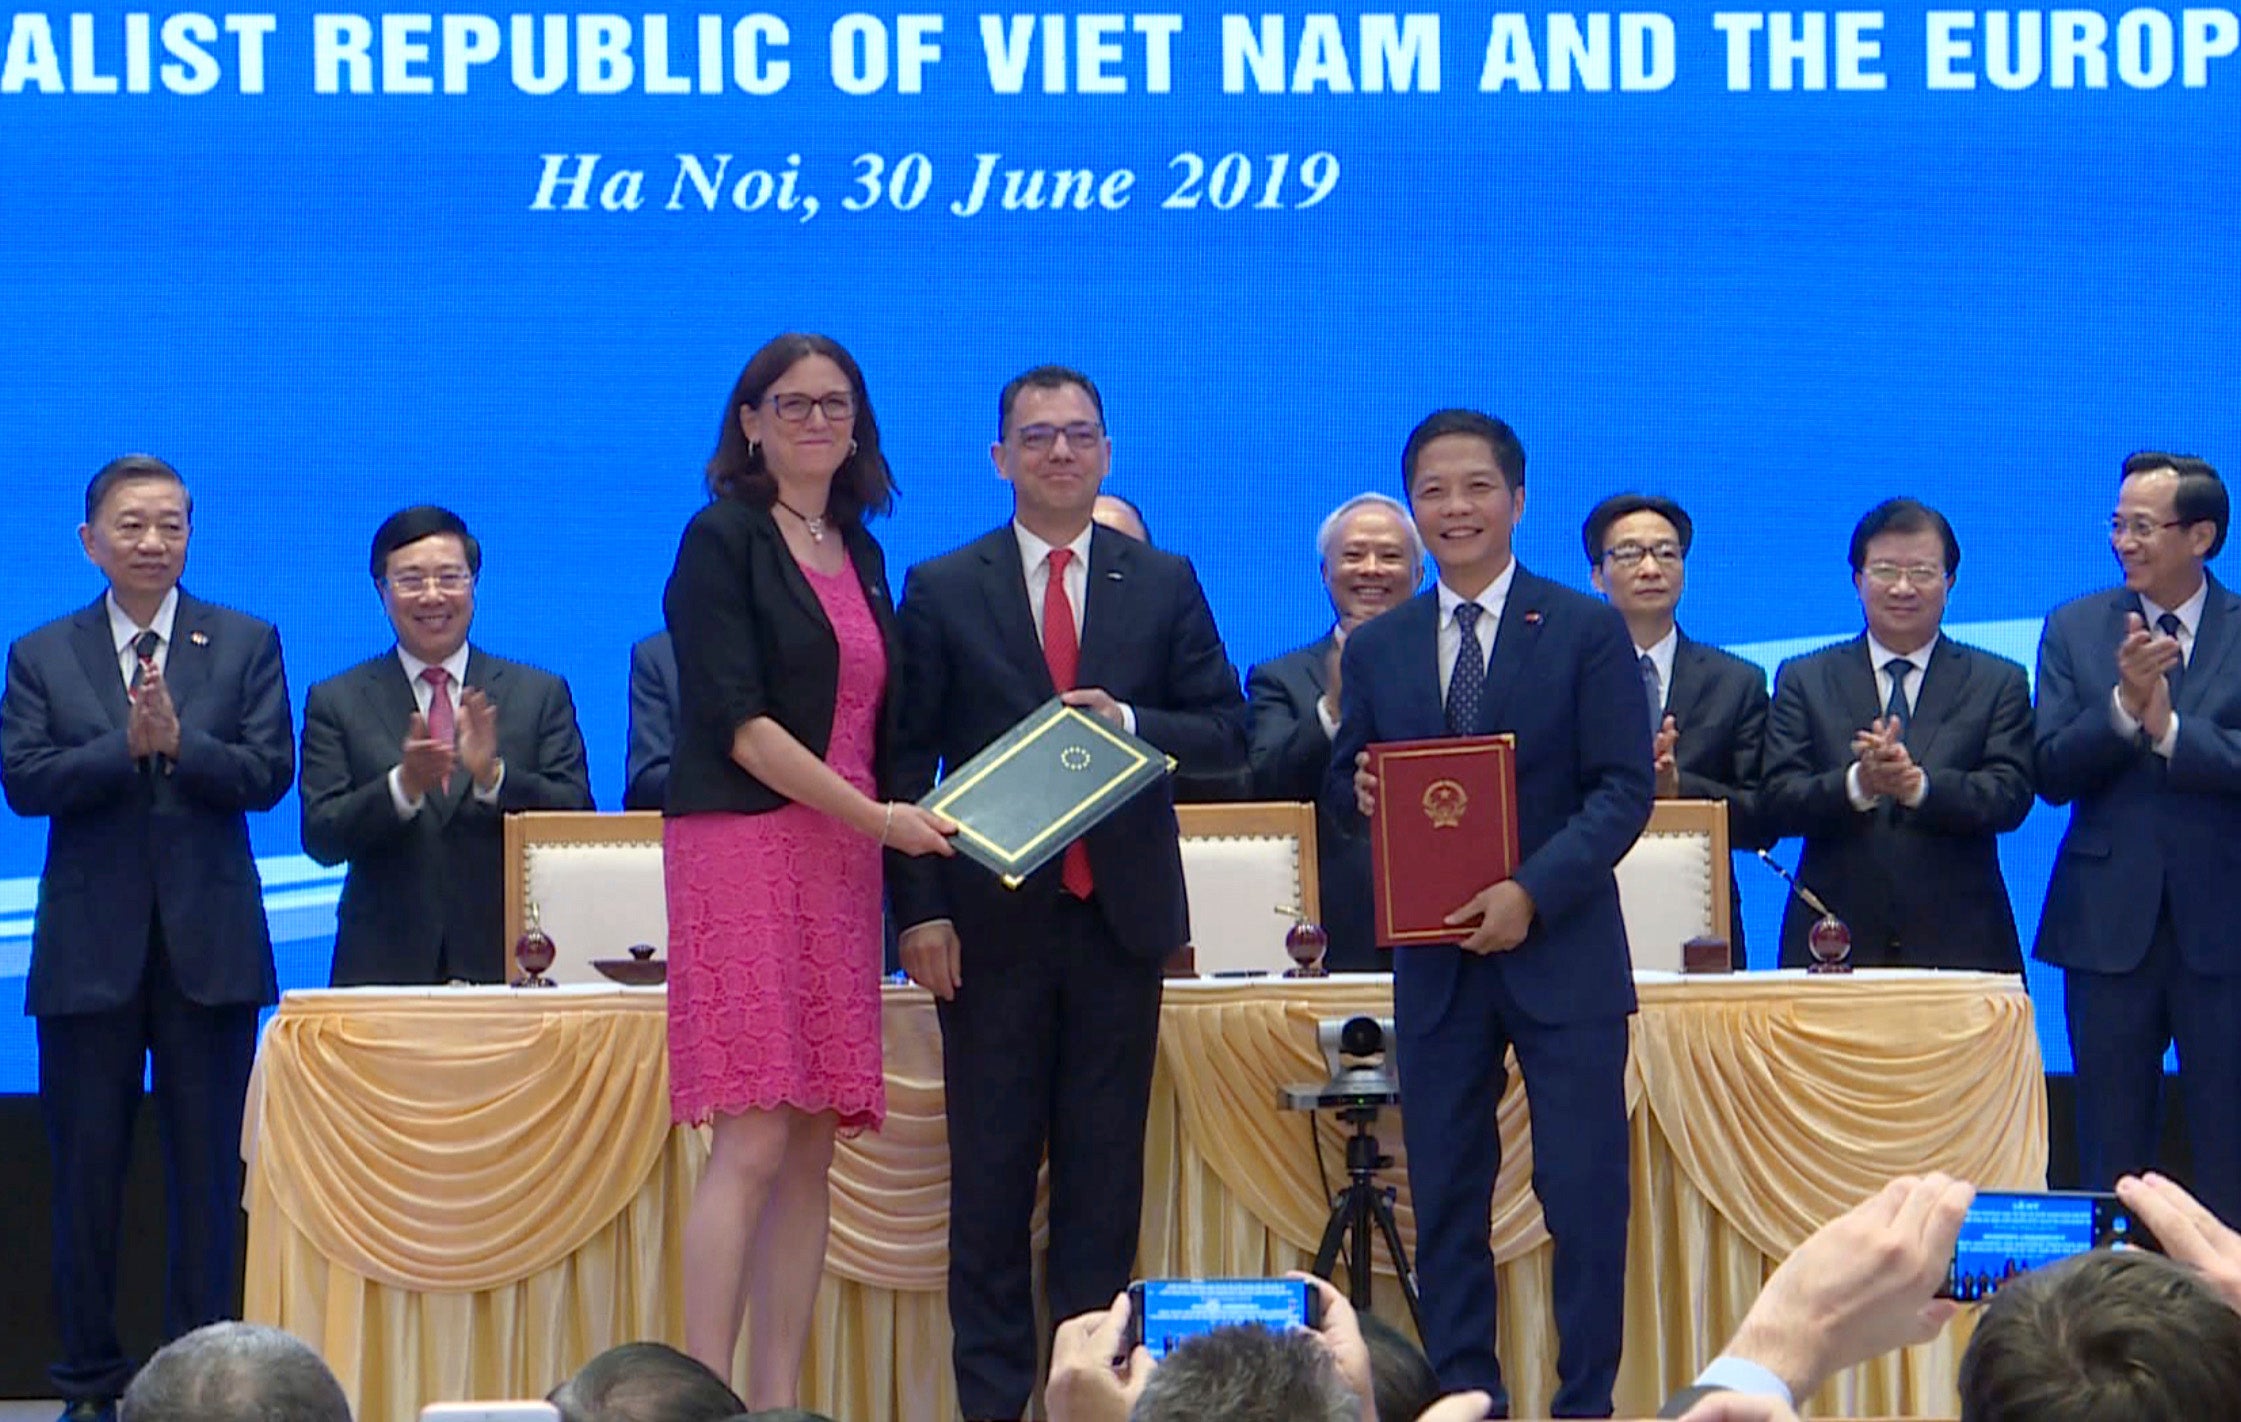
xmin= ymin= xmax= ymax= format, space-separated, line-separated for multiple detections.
xmin=1324 ymin=567 xmax=1652 ymax=1023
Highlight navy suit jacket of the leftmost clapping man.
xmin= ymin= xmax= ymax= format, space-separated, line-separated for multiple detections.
xmin=0 ymin=589 xmax=296 ymax=1017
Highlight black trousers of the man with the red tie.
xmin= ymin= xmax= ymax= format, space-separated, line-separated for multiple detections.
xmin=939 ymin=896 xmax=1161 ymax=1418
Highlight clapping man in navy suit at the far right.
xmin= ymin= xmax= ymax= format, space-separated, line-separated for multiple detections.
xmin=2035 ymin=452 xmax=2241 ymax=1220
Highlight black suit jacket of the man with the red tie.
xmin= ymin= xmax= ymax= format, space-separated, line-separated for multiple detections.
xmin=887 ymin=524 xmax=1246 ymax=961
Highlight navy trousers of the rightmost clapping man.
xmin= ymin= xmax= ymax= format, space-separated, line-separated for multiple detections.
xmin=2064 ymin=900 xmax=2241 ymax=1223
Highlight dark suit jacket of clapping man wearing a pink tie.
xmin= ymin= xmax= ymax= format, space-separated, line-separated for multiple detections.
xmin=298 ymin=647 xmax=592 ymax=988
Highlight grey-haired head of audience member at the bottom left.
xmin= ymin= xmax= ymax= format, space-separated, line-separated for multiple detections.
xmin=119 ymin=1323 xmax=350 ymax=1422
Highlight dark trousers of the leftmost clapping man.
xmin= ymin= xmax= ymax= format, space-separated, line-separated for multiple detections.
xmin=38 ymin=925 xmax=258 ymax=1400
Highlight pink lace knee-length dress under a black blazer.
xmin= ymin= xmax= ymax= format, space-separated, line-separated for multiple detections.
xmin=661 ymin=567 xmax=887 ymax=1133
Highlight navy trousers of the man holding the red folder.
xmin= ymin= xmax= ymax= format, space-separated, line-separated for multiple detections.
xmin=1394 ymin=947 xmax=1629 ymax=1418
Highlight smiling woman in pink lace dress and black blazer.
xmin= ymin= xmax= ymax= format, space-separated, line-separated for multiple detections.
xmin=661 ymin=336 xmax=952 ymax=1409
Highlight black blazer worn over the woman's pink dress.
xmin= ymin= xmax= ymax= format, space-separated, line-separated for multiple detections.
xmin=661 ymin=497 xmax=903 ymax=815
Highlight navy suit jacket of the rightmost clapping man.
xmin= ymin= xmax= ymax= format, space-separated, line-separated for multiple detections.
xmin=2035 ymin=573 xmax=2241 ymax=974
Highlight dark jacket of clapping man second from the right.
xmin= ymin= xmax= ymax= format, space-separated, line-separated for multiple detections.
xmin=1759 ymin=636 xmax=2030 ymax=972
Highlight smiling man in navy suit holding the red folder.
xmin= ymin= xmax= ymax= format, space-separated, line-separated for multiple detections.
xmin=1324 ymin=410 xmax=1652 ymax=1418
